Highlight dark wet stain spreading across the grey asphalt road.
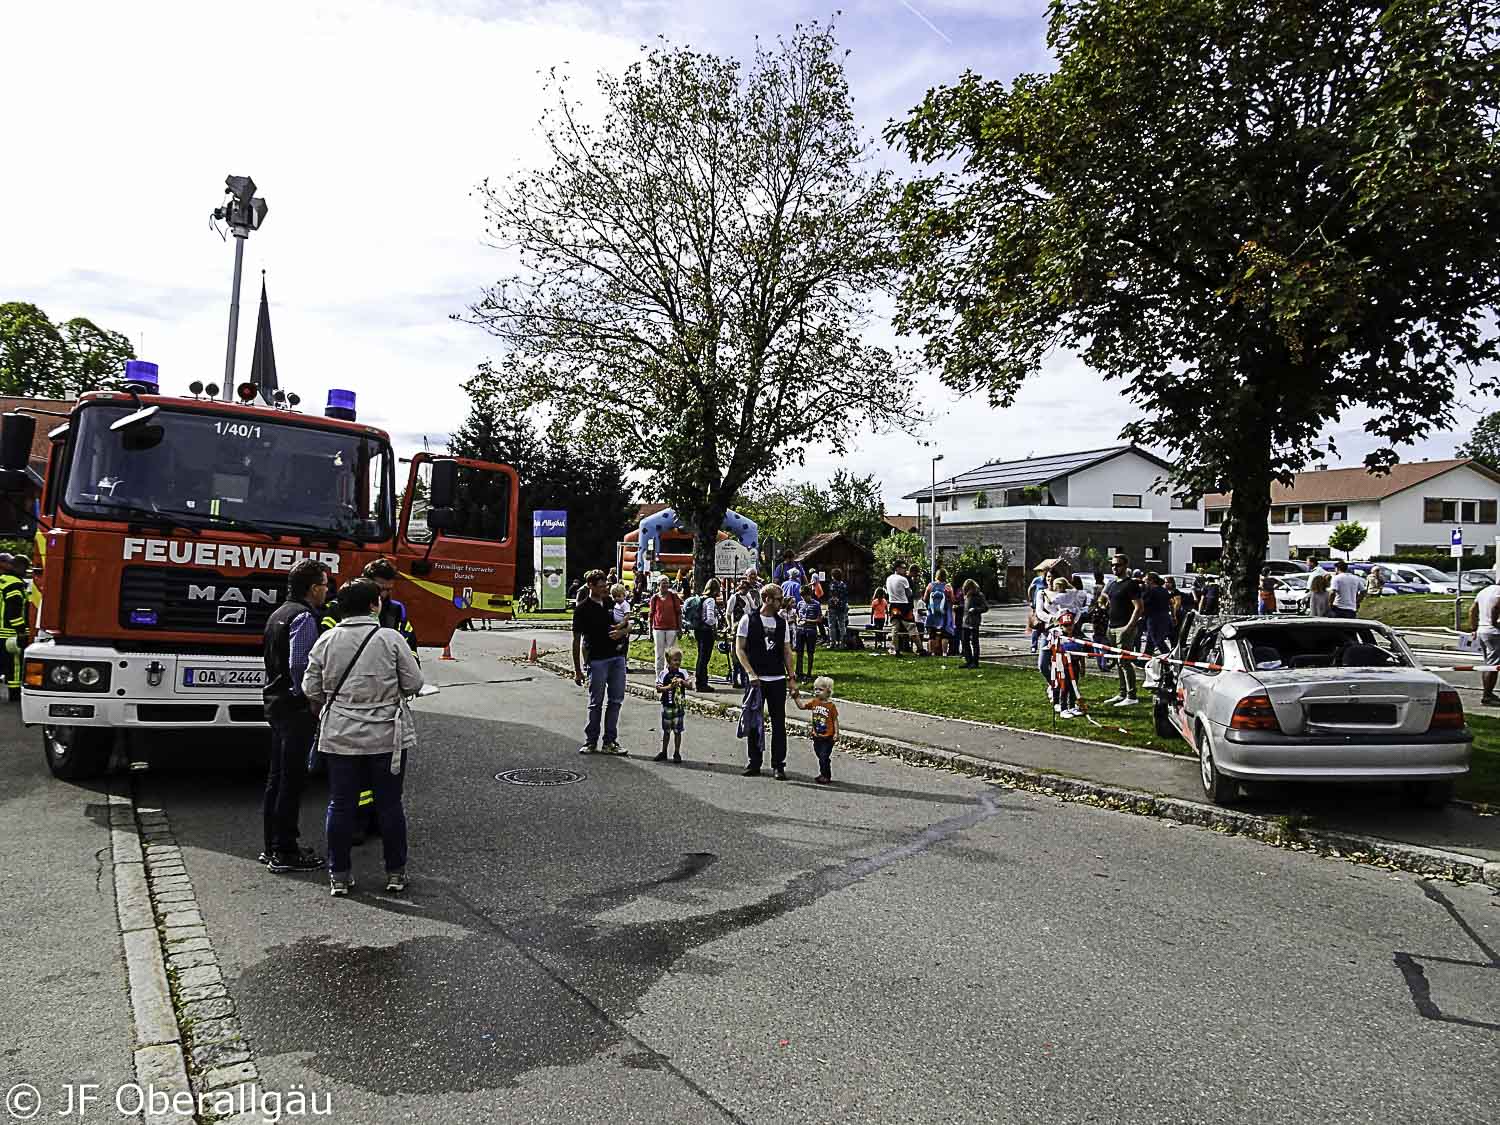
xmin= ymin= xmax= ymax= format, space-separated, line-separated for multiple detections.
xmin=236 ymin=792 xmax=1001 ymax=1098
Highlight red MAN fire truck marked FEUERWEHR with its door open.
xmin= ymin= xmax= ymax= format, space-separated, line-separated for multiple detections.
xmin=0 ymin=375 xmax=518 ymax=779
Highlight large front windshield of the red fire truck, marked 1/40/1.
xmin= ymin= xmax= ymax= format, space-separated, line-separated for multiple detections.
xmin=63 ymin=402 xmax=395 ymax=542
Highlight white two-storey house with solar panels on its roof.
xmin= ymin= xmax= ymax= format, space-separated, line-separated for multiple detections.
xmin=903 ymin=446 xmax=1289 ymax=596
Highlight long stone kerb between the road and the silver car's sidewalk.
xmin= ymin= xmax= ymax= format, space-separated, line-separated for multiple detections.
xmin=537 ymin=659 xmax=1500 ymax=888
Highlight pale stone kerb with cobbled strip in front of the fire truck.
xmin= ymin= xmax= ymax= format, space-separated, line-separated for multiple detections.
xmin=110 ymin=780 xmax=260 ymax=1125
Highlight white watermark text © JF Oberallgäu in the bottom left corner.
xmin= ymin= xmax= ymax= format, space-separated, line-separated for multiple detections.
xmin=5 ymin=1082 xmax=333 ymax=1125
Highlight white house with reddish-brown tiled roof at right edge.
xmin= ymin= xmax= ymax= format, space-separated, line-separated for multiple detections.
xmin=1203 ymin=459 xmax=1500 ymax=558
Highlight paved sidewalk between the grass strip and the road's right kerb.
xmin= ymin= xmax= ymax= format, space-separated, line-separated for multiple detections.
xmin=459 ymin=630 xmax=1500 ymax=863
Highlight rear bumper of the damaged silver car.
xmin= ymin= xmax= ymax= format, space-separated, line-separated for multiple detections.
xmin=1214 ymin=729 xmax=1473 ymax=782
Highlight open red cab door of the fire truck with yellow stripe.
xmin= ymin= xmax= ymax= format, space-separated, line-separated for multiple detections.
xmin=396 ymin=453 xmax=521 ymax=645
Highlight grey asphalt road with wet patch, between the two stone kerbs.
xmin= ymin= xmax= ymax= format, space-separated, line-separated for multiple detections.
xmin=0 ymin=638 xmax=1500 ymax=1124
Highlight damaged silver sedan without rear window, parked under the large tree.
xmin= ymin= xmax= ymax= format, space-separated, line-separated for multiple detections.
xmin=1155 ymin=617 xmax=1473 ymax=807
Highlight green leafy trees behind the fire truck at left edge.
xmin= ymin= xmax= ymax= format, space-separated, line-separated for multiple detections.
xmin=0 ymin=302 xmax=135 ymax=399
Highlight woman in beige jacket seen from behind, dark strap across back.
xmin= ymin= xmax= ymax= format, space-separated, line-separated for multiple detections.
xmin=302 ymin=578 xmax=422 ymax=897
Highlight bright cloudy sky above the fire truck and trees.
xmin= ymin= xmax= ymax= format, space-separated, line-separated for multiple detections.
xmin=0 ymin=0 xmax=1487 ymax=512
